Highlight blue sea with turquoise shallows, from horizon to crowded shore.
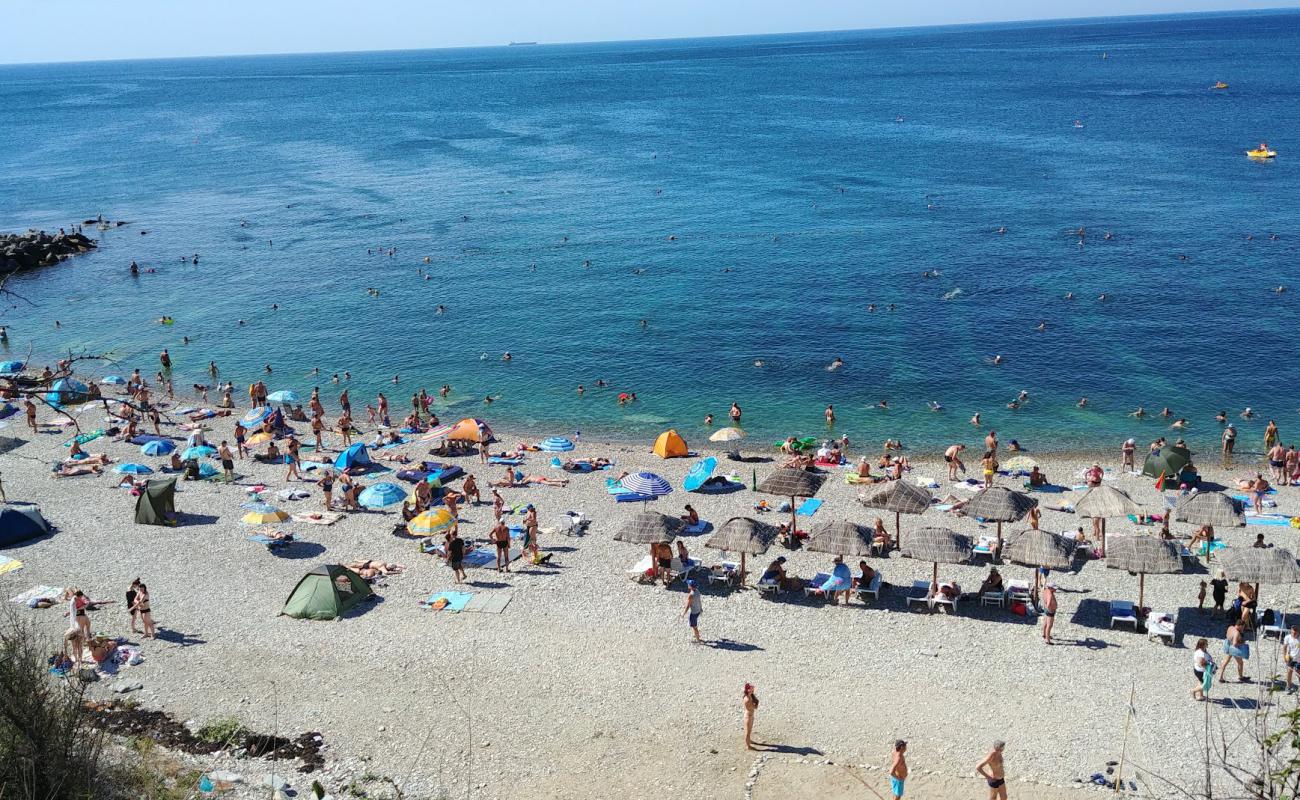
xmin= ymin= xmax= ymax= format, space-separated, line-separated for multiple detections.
xmin=0 ymin=13 xmax=1300 ymax=449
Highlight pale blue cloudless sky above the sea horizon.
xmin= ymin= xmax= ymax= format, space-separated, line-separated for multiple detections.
xmin=0 ymin=0 xmax=1300 ymax=64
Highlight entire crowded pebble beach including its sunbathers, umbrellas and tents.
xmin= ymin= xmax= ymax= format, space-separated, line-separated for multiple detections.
xmin=0 ymin=351 xmax=1300 ymax=799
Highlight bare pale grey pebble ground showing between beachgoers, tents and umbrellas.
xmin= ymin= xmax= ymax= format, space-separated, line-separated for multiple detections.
xmin=0 ymin=392 xmax=1300 ymax=799
